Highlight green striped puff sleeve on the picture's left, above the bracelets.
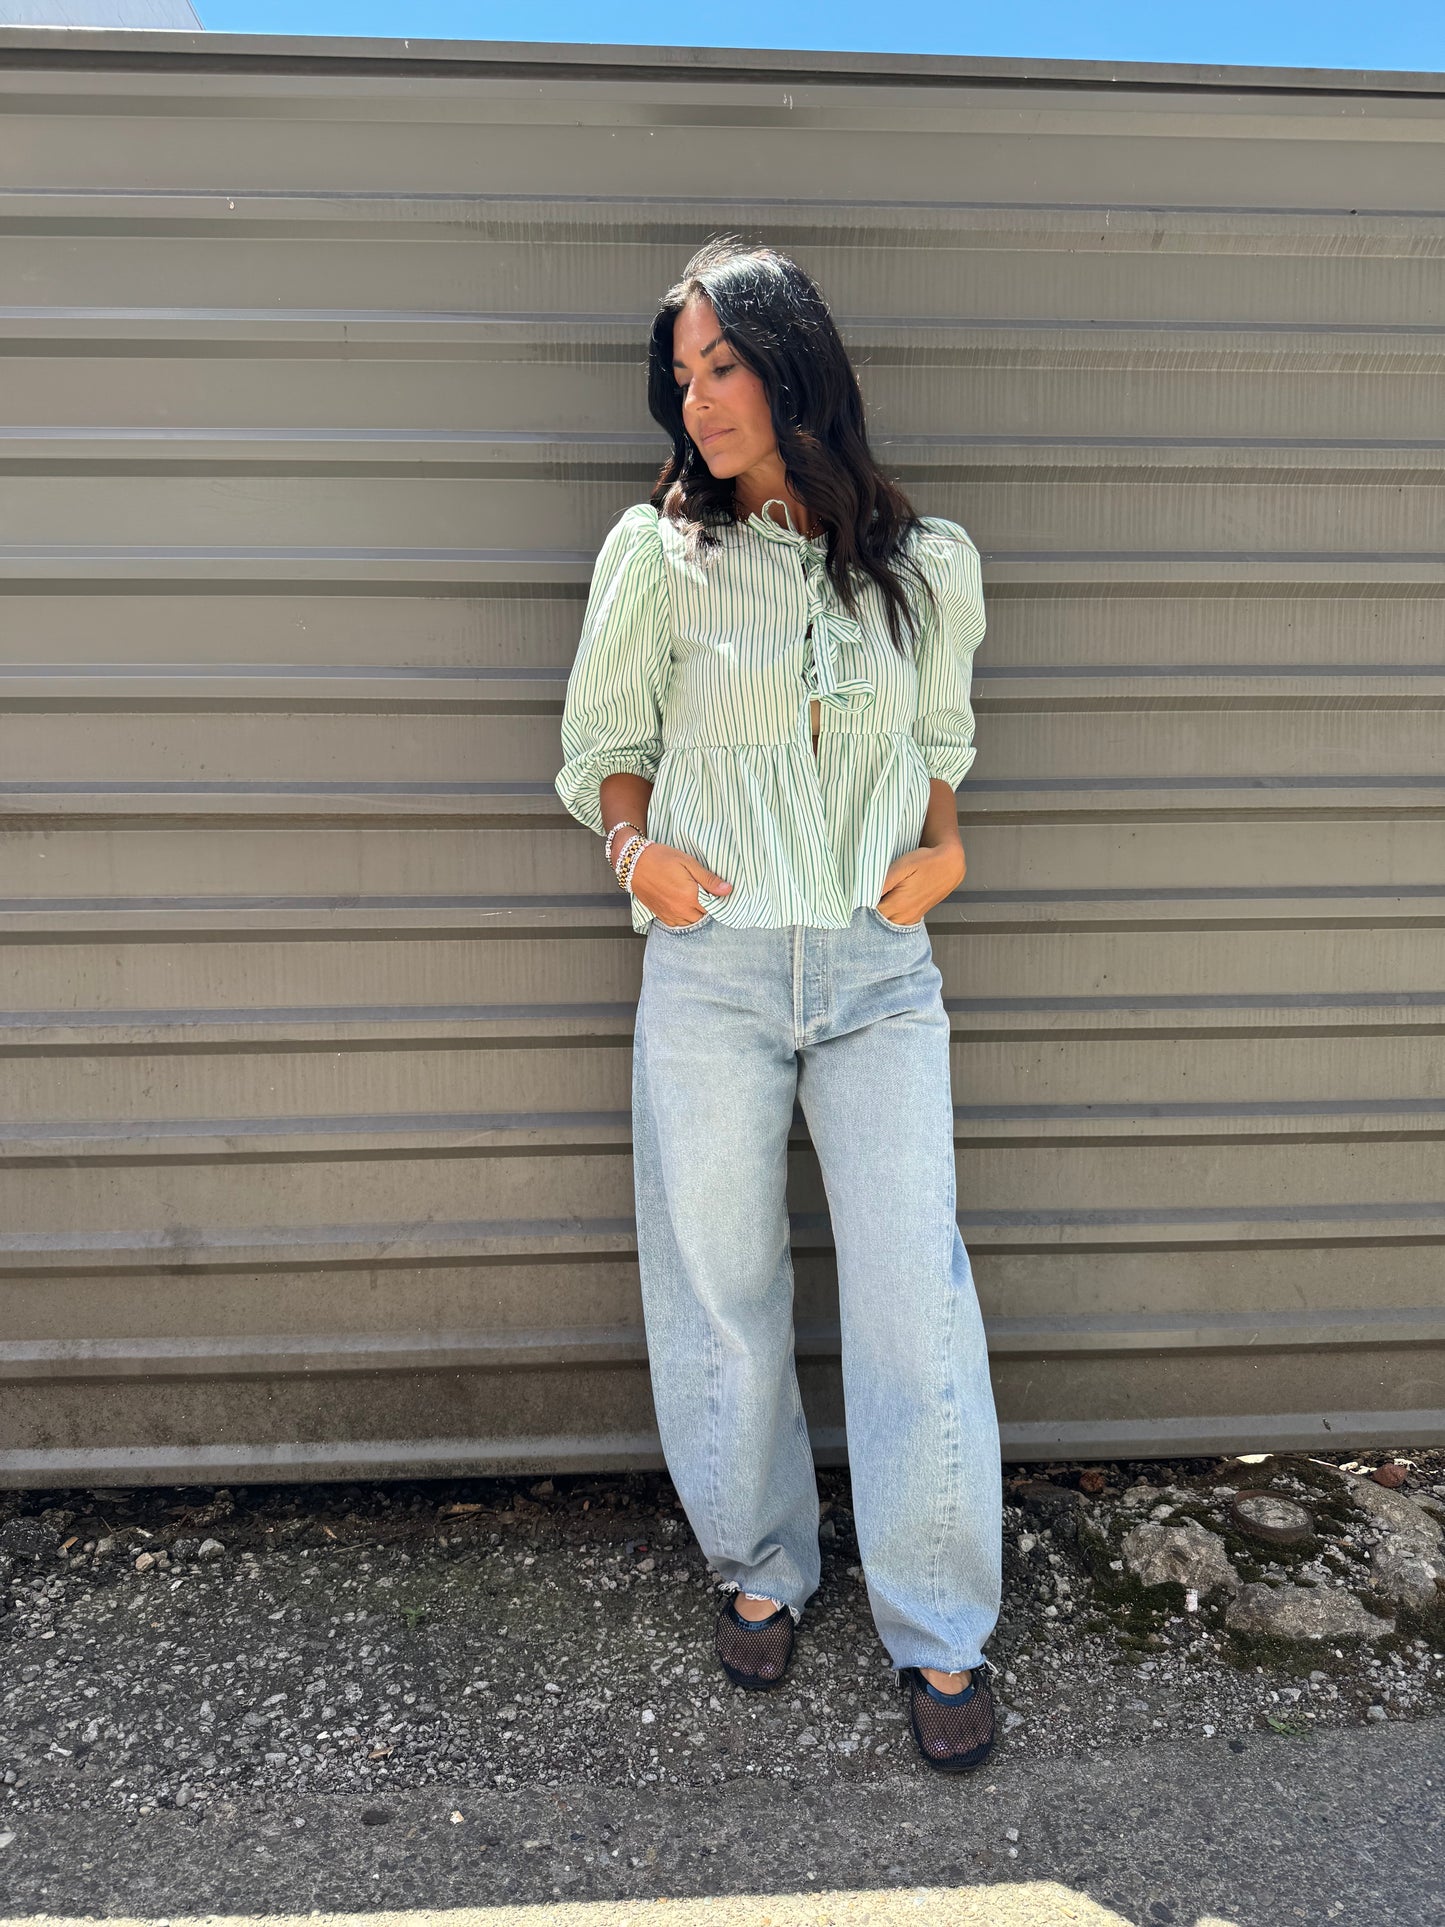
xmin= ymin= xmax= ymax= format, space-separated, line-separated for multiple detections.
xmin=555 ymin=501 xmax=672 ymax=836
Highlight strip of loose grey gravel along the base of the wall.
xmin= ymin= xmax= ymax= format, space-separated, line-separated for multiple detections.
xmin=0 ymin=1453 xmax=1445 ymax=1846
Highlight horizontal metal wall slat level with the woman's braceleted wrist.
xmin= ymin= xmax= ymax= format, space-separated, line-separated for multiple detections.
xmin=0 ymin=813 xmax=1445 ymax=886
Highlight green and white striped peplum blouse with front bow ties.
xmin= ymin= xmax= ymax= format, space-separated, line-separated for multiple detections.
xmin=555 ymin=503 xmax=985 ymax=931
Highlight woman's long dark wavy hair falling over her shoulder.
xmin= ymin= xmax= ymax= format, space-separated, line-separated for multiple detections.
xmin=647 ymin=235 xmax=933 ymax=651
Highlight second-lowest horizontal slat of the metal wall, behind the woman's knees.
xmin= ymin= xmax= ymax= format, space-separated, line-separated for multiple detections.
xmin=4 ymin=1240 xmax=1439 ymax=1355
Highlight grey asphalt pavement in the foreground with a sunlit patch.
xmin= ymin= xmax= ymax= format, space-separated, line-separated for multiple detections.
xmin=0 ymin=1719 xmax=1445 ymax=1927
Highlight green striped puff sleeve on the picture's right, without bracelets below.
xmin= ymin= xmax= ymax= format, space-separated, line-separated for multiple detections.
xmin=913 ymin=516 xmax=985 ymax=790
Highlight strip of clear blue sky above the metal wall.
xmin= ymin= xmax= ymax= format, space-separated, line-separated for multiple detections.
xmin=195 ymin=0 xmax=1445 ymax=73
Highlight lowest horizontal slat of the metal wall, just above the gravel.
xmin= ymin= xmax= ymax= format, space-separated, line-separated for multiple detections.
xmin=0 ymin=1355 xmax=1445 ymax=1486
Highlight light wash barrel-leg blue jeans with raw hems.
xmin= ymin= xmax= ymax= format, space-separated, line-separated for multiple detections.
xmin=632 ymin=904 xmax=1002 ymax=1673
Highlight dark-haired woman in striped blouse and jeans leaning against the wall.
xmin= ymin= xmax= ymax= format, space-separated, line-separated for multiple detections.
xmin=557 ymin=239 xmax=1002 ymax=1771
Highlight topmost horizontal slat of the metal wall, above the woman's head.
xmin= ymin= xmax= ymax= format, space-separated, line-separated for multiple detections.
xmin=0 ymin=106 xmax=1439 ymax=211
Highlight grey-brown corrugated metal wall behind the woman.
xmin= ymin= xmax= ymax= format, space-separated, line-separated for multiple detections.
xmin=0 ymin=31 xmax=1445 ymax=1484
